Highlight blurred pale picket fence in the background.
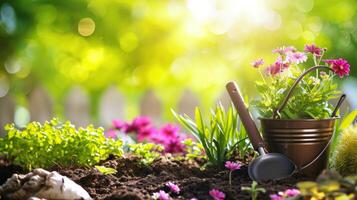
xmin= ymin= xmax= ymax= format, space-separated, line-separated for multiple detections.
xmin=0 ymin=86 xmax=229 ymax=135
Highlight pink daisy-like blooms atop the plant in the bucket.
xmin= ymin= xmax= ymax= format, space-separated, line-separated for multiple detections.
xmin=251 ymin=44 xmax=350 ymax=78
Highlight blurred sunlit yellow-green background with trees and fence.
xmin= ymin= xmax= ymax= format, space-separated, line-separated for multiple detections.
xmin=0 ymin=0 xmax=357 ymax=131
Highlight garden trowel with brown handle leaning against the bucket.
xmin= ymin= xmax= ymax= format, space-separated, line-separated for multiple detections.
xmin=226 ymin=82 xmax=297 ymax=182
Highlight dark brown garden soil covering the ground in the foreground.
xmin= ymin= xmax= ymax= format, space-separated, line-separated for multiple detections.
xmin=0 ymin=156 xmax=307 ymax=200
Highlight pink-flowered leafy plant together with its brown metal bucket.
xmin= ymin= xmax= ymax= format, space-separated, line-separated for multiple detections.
xmin=252 ymin=44 xmax=350 ymax=176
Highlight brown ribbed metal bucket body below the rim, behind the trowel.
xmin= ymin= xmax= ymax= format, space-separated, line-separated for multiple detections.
xmin=260 ymin=118 xmax=337 ymax=177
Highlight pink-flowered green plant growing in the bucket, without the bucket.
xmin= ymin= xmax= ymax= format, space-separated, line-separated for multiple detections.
xmin=253 ymin=45 xmax=350 ymax=119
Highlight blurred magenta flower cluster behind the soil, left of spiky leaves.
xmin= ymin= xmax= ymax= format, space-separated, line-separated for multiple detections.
xmin=107 ymin=116 xmax=187 ymax=153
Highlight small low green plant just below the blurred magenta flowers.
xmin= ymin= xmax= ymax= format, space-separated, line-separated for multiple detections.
xmin=128 ymin=143 xmax=164 ymax=166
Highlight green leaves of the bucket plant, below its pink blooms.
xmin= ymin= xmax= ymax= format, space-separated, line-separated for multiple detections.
xmin=253 ymin=67 xmax=340 ymax=119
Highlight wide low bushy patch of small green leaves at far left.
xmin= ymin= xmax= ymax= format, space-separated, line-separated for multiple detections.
xmin=0 ymin=119 xmax=123 ymax=170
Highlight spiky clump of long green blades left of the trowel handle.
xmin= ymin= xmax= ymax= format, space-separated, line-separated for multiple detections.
xmin=172 ymin=104 xmax=251 ymax=166
